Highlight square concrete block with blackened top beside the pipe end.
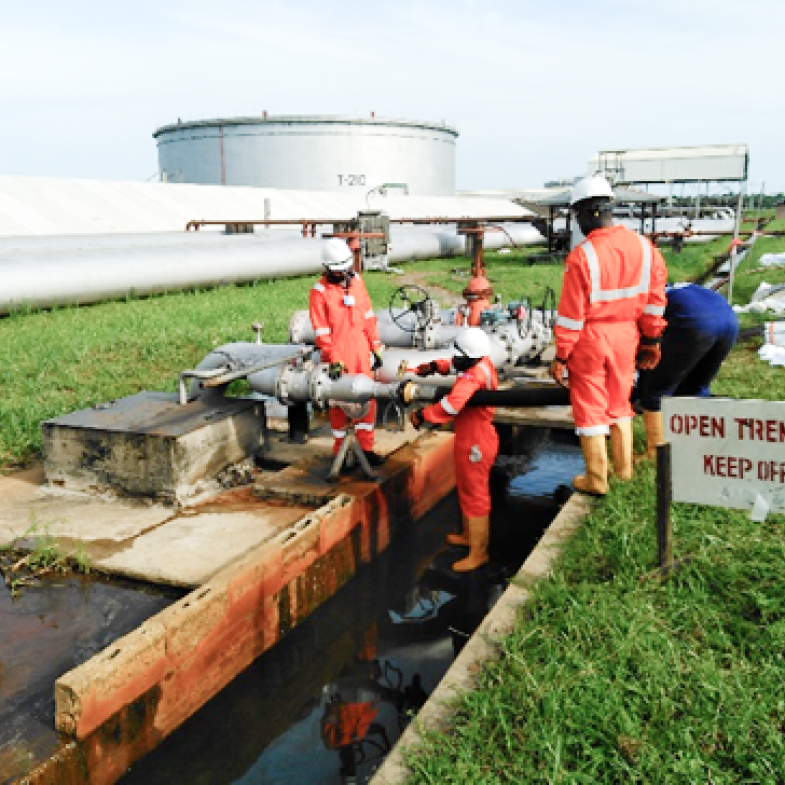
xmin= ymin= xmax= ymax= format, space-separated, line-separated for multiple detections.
xmin=42 ymin=392 xmax=264 ymax=502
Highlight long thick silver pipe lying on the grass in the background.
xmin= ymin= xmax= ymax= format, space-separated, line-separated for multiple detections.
xmin=0 ymin=225 xmax=543 ymax=314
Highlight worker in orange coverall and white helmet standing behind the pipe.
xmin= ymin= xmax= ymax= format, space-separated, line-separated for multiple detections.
xmin=309 ymin=238 xmax=384 ymax=466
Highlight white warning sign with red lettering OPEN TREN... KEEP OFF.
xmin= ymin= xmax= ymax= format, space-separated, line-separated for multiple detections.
xmin=662 ymin=398 xmax=785 ymax=517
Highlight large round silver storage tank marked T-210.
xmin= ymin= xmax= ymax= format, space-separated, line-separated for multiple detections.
xmin=153 ymin=115 xmax=458 ymax=196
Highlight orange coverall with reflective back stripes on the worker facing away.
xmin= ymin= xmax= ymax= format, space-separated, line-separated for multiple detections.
xmin=554 ymin=226 xmax=668 ymax=436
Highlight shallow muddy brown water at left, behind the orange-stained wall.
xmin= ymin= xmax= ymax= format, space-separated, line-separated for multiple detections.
xmin=0 ymin=576 xmax=182 ymax=783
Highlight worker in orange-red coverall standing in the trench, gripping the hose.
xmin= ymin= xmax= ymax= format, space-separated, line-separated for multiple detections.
xmin=410 ymin=327 xmax=499 ymax=572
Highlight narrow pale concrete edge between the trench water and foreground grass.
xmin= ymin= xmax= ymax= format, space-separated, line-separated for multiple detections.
xmin=370 ymin=493 xmax=594 ymax=785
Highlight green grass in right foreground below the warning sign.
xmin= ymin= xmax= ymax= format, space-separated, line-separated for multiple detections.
xmin=409 ymin=462 xmax=785 ymax=785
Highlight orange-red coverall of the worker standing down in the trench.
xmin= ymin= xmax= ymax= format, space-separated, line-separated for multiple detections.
xmin=422 ymin=357 xmax=499 ymax=518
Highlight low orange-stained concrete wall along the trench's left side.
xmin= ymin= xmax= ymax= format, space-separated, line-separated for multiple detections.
xmin=22 ymin=433 xmax=455 ymax=785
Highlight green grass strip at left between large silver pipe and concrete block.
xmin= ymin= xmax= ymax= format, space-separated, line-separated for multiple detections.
xmin=0 ymin=273 xmax=399 ymax=467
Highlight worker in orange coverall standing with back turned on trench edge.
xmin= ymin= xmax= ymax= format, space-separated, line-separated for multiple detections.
xmin=550 ymin=176 xmax=668 ymax=496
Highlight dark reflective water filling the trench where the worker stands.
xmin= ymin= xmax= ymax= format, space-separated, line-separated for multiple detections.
xmin=122 ymin=430 xmax=583 ymax=785
